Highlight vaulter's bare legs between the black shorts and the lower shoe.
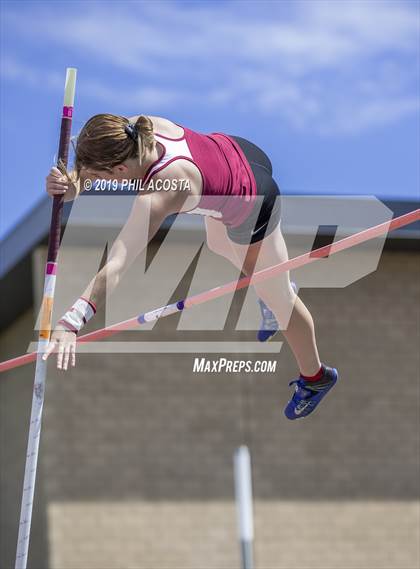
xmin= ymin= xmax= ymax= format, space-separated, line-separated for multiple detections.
xmin=206 ymin=218 xmax=321 ymax=376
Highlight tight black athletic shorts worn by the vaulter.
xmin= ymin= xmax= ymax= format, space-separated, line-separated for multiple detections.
xmin=227 ymin=135 xmax=280 ymax=245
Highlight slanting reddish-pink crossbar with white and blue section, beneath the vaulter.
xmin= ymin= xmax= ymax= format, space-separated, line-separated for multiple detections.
xmin=0 ymin=209 xmax=420 ymax=373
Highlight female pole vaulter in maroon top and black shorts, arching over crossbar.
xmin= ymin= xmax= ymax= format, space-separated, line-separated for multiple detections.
xmin=44 ymin=114 xmax=338 ymax=420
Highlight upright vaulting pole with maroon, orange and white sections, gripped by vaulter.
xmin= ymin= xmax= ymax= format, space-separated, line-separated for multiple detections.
xmin=15 ymin=68 xmax=77 ymax=569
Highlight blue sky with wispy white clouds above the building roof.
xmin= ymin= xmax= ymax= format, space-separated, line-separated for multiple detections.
xmin=0 ymin=0 xmax=420 ymax=236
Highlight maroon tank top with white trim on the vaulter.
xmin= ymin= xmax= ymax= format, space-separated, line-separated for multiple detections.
xmin=143 ymin=125 xmax=257 ymax=227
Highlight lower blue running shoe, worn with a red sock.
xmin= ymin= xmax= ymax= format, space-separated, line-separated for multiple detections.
xmin=284 ymin=366 xmax=338 ymax=421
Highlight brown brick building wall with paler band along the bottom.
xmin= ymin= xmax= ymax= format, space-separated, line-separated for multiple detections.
xmin=0 ymin=244 xmax=420 ymax=569
